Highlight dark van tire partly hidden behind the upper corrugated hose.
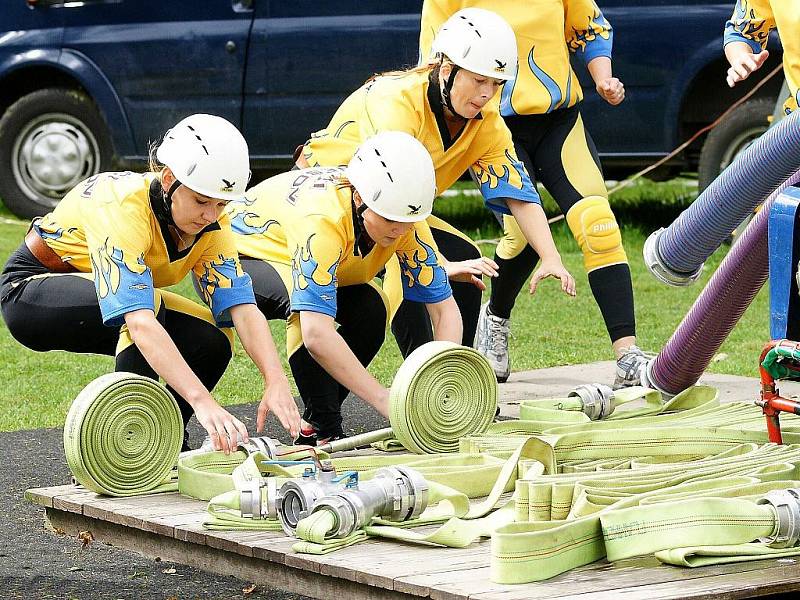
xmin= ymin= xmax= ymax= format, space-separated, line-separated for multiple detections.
xmin=697 ymin=98 xmax=775 ymax=192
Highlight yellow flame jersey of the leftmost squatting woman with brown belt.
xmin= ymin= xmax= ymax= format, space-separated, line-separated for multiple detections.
xmin=33 ymin=172 xmax=255 ymax=327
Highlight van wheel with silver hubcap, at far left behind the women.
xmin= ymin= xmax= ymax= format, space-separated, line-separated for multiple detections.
xmin=0 ymin=88 xmax=113 ymax=219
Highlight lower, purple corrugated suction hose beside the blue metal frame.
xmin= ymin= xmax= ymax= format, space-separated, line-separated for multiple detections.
xmin=648 ymin=170 xmax=800 ymax=394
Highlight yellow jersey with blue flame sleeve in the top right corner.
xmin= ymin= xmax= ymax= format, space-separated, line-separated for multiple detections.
xmin=724 ymin=0 xmax=800 ymax=115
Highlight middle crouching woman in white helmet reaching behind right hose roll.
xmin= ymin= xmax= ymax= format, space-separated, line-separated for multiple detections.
xmin=226 ymin=132 xmax=462 ymax=444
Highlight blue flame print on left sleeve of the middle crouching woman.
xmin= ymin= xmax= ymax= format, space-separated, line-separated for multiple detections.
xmin=291 ymin=233 xmax=342 ymax=317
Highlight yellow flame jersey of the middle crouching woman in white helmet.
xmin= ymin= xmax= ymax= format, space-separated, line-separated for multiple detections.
xmin=225 ymin=168 xmax=452 ymax=317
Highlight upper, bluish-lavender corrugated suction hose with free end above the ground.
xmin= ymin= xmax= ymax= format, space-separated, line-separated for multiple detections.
xmin=657 ymin=111 xmax=800 ymax=273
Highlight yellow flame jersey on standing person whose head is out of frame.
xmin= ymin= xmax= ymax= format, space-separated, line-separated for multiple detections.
xmin=419 ymin=0 xmax=613 ymax=116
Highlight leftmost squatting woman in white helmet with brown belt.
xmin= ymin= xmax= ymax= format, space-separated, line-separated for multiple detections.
xmin=0 ymin=114 xmax=300 ymax=452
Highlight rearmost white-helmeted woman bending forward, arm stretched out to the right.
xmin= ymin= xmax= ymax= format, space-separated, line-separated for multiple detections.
xmin=296 ymin=9 xmax=575 ymax=376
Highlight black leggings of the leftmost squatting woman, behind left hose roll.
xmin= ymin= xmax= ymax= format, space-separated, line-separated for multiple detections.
xmin=0 ymin=244 xmax=231 ymax=448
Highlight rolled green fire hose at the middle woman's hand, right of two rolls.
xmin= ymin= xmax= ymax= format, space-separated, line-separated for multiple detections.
xmin=320 ymin=342 xmax=497 ymax=454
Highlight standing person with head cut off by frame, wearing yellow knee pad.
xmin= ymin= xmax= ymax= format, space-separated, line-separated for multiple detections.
xmin=420 ymin=0 xmax=648 ymax=387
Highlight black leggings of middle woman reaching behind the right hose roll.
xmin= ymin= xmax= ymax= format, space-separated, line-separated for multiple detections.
xmin=241 ymin=257 xmax=387 ymax=438
